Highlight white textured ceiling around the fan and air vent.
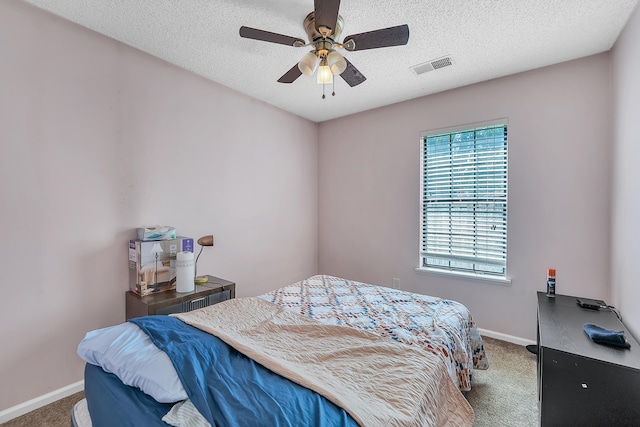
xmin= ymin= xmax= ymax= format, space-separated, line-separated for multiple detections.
xmin=26 ymin=0 xmax=638 ymax=122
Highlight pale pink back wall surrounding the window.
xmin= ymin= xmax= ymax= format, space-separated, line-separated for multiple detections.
xmin=318 ymin=54 xmax=612 ymax=340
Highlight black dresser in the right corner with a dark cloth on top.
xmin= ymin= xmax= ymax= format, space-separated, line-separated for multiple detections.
xmin=537 ymin=292 xmax=640 ymax=427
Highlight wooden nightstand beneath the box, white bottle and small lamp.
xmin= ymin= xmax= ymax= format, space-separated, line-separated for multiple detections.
xmin=126 ymin=276 xmax=236 ymax=320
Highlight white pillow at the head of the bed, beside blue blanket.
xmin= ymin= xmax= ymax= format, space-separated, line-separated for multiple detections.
xmin=78 ymin=322 xmax=188 ymax=403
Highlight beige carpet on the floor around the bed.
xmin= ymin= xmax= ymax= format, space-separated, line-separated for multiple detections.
xmin=1 ymin=338 xmax=538 ymax=427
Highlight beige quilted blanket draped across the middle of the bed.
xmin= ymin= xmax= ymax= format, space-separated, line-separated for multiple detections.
xmin=172 ymin=297 xmax=474 ymax=427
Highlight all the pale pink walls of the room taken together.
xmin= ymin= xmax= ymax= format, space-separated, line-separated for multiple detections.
xmin=0 ymin=0 xmax=640 ymax=418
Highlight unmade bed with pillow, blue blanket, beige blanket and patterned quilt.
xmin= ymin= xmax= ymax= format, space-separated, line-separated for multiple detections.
xmin=72 ymin=275 xmax=488 ymax=427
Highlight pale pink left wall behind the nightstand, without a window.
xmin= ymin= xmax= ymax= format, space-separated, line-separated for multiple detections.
xmin=0 ymin=0 xmax=318 ymax=411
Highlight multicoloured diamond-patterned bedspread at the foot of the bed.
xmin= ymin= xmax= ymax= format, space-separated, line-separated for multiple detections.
xmin=260 ymin=275 xmax=489 ymax=391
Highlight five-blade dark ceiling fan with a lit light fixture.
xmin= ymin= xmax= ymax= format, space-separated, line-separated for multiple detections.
xmin=240 ymin=0 xmax=409 ymax=98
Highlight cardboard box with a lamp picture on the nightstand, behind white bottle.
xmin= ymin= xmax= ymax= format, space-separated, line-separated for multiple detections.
xmin=129 ymin=236 xmax=194 ymax=296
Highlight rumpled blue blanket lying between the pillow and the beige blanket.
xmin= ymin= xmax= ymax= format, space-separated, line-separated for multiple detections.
xmin=130 ymin=316 xmax=358 ymax=427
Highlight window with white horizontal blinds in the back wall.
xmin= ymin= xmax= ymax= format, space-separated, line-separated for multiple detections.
xmin=420 ymin=121 xmax=507 ymax=277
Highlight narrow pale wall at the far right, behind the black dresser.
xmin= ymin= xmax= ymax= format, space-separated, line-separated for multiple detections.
xmin=611 ymin=2 xmax=640 ymax=339
